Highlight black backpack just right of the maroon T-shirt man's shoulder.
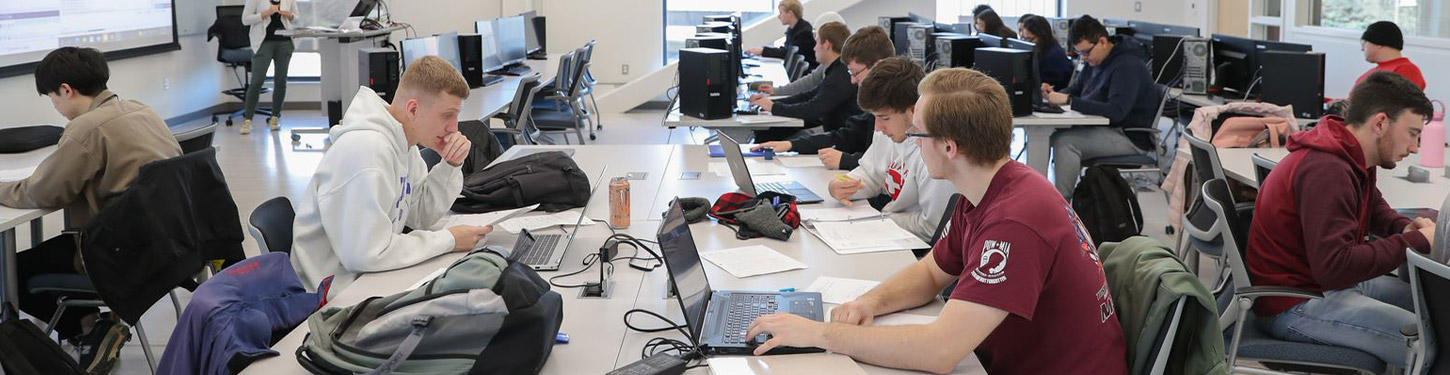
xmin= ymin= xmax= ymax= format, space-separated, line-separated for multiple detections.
xmin=1073 ymin=167 xmax=1143 ymax=245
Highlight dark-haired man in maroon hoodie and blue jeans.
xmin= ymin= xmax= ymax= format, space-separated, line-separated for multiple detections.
xmin=1244 ymin=71 xmax=1436 ymax=368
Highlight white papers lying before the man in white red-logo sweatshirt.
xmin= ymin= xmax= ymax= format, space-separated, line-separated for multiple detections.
xmin=809 ymin=219 xmax=931 ymax=255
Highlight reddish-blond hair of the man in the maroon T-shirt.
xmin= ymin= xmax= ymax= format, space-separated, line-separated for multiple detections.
xmin=916 ymin=68 xmax=1012 ymax=165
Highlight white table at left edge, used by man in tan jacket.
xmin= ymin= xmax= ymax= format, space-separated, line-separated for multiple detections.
xmin=0 ymin=146 xmax=57 ymax=319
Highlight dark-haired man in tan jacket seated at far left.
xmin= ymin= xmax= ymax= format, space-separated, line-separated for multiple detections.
xmin=0 ymin=46 xmax=181 ymax=374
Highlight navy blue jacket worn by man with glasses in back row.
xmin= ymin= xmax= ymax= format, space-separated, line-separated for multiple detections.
xmin=1066 ymin=35 xmax=1161 ymax=149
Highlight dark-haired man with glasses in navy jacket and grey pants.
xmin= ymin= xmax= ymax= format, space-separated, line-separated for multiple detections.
xmin=1043 ymin=16 xmax=1161 ymax=197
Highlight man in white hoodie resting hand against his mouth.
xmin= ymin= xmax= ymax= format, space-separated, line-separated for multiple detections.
xmin=291 ymin=56 xmax=493 ymax=297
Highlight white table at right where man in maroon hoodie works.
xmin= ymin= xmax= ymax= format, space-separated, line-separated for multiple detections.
xmin=1218 ymin=148 xmax=1450 ymax=208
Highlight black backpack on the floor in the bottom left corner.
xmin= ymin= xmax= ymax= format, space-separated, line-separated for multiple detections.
xmin=0 ymin=304 xmax=86 ymax=375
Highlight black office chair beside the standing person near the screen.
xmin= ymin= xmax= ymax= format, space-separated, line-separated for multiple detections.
xmin=206 ymin=6 xmax=273 ymax=126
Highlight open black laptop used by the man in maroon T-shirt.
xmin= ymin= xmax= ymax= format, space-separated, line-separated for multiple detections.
xmin=657 ymin=198 xmax=825 ymax=355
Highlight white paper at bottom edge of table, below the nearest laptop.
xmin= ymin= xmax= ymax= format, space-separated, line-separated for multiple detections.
xmin=709 ymin=353 xmax=866 ymax=375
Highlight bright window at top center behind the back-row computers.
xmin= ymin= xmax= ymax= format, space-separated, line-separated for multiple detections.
xmin=664 ymin=0 xmax=783 ymax=64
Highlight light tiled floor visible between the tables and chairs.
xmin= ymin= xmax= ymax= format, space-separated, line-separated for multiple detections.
xmin=19 ymin=110 xmax=1173 ymax=374
